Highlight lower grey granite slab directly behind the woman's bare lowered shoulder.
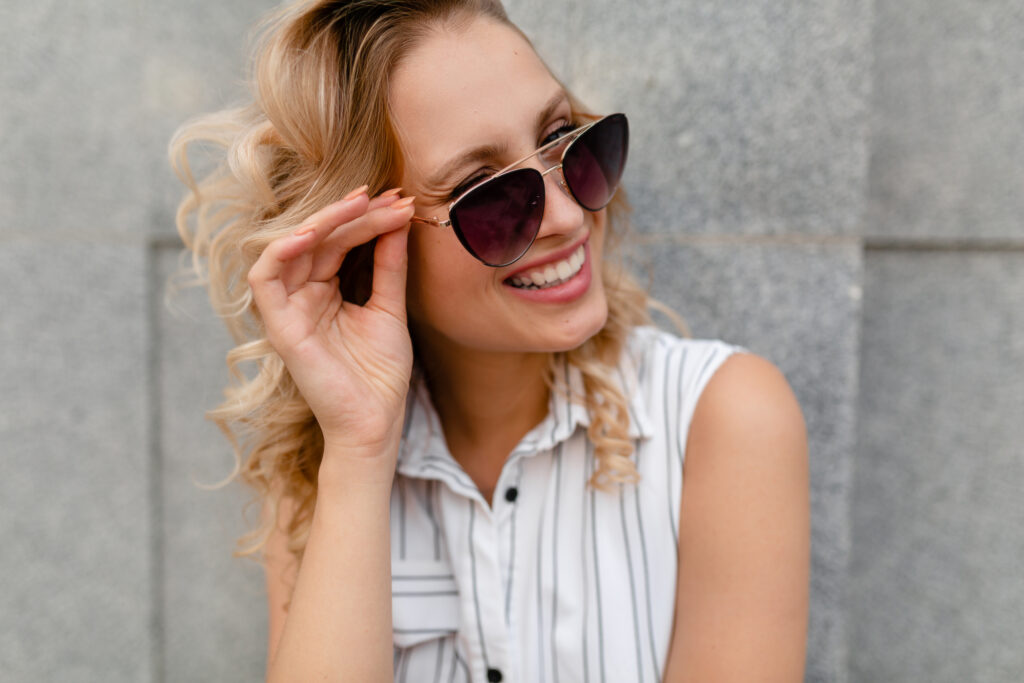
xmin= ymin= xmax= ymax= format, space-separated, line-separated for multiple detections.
xmin=637 ymin=241 xmax=861 ymax=681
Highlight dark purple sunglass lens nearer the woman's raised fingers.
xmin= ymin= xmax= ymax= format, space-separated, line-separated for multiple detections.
xmin=451 ymin=168 xmax=544 ymax=265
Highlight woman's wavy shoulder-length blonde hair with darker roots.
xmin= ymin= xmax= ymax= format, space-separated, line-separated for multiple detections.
xmin=169 ymin=0 xmax=679 ymax=558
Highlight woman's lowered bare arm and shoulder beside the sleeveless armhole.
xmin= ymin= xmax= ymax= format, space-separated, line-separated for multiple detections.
xmin=665 ymin=353 xmax=810 ymax=683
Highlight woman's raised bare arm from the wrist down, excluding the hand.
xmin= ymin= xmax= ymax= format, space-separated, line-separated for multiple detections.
xmin=266 ymin=454 xmax=393 ymax=682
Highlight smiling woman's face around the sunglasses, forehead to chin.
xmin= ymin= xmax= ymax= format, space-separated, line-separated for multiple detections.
xmin=390 ymin=18 xmax=607 ymax=352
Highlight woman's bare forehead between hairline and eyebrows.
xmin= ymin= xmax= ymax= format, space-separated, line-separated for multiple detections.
xmin=390 ymin=18 xmax=560 ymax=183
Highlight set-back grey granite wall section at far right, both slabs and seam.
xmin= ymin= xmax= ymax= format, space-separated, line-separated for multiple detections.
xmin=846 ymin=0 xmax=1024 ymax=681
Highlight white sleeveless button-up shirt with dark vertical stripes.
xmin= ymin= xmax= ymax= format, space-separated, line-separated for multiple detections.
xmin=390 ymin=328 xmax=746 ymax=683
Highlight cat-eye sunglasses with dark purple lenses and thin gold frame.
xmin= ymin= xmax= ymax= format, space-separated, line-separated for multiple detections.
xmin=412 ymin=114 xmax=630 ymax=267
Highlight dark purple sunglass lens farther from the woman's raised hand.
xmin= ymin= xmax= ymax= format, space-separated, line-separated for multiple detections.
xmin=562 ymin=114 xmax=630 ymax=211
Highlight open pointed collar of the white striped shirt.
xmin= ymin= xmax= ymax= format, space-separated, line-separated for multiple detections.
xmin=397 ymin=351 xmax=652 ymax=487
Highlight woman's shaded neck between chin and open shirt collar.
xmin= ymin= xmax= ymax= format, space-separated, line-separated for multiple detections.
xmin=417 ymin=327 xmax=549 ymax=471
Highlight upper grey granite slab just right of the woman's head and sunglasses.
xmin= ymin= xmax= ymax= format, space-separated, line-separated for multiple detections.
xmin=538 ymin=0 xmax=871 ymax=239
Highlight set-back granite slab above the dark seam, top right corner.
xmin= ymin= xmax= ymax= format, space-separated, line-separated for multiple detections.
xmin=865 ymin=0 xmax=1024 ymax=240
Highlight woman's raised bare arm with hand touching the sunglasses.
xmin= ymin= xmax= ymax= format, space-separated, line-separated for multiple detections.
xmin=248 ymin=186 xmax=413 ymax=683
